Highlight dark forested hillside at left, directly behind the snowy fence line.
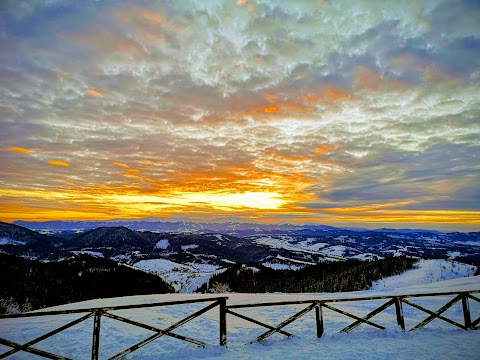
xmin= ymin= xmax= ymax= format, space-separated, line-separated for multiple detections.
xmin=0 ymin=253 xmax=175 ymax=313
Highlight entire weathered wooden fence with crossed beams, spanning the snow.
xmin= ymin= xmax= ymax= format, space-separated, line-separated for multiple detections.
xmin=0 ymin=290 xmax=480 ymax=360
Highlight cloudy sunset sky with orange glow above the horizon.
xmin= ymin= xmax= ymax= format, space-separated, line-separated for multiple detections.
xmin=0 ymin=0 xmax=480 ymax=231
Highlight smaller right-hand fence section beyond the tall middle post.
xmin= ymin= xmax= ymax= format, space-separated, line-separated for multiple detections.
xmin=227 ymin=292 xmax=480 ymax=341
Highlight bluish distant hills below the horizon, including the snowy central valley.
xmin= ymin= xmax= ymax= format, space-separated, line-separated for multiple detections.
xmin=0 ymin=220 xmax=480 ymax=300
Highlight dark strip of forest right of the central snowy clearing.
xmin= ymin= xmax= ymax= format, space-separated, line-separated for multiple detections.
xmin=198 ymin=257 xmax=417 ymax=293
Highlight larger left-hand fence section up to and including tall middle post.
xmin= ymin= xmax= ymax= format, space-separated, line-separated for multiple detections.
xmin=0 ymin=297 xmax=227 ymax=360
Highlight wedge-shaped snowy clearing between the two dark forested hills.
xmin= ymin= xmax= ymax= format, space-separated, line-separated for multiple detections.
xmin=133 ymin=259 xmax=226 ymax=293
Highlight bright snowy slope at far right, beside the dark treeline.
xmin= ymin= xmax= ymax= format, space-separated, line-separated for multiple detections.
xmin=372 ymin=260 xmax=476 ymax=291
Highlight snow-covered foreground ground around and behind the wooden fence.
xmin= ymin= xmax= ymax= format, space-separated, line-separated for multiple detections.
xmin=0 ymin=276 xmax=480 ymax=360
